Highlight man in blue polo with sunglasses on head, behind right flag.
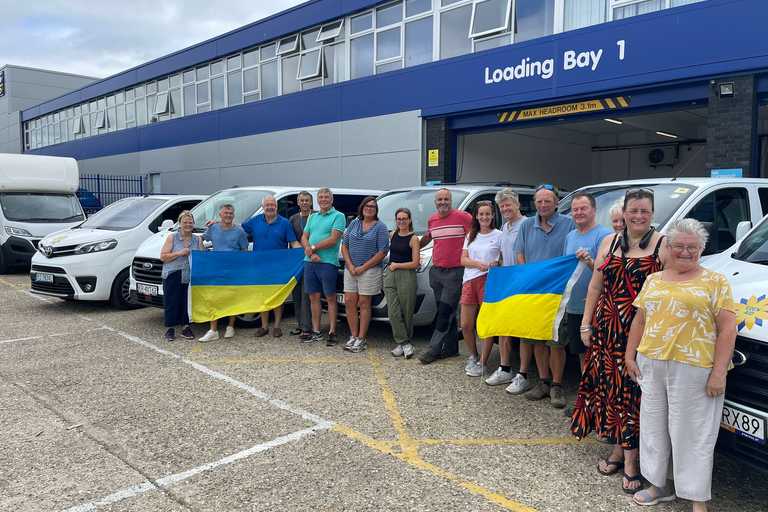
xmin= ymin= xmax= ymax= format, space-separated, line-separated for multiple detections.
xmin=510 ymin=185 xmax=573 ymax=408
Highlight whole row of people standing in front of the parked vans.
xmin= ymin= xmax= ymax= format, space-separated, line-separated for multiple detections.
xmin=161 ymin=185 xmax=736 ymax=512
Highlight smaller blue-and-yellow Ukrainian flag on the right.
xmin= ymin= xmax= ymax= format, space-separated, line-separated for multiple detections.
xmin=477 ymin=256 xmax=584 ymax=340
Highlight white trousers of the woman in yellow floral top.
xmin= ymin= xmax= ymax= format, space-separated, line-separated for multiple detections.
xmin=637 ymin=354 xmax=724 ymax=501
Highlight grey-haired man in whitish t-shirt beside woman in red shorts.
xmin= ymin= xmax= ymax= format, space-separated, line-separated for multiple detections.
xmin=485 ymin=188 xmax=525 ymax=389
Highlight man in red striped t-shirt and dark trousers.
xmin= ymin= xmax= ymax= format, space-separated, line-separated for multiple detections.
xmin=419 ymin=188 xmax=472 ymax=364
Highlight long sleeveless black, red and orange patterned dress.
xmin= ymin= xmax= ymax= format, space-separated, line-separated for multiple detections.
xmin=571 ymin=237 xmax=662 ymax=450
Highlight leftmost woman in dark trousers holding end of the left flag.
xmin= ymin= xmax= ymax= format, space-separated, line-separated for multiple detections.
xmin=160 ymin=210 xmax=200 ymax=341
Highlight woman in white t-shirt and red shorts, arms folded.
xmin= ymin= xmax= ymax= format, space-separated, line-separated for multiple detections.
xmin=459 ymin=201 xmax=502 ymax=377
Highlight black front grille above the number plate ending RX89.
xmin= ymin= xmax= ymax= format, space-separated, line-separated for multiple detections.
xmin=725 ymin=336 xmax=768 ymax=412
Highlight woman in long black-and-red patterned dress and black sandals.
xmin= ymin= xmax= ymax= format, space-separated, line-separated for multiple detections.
xmin=571 ymin=189 xmax=664 ymax=494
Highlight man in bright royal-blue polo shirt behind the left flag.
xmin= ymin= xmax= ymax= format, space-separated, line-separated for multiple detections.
xmin=243 ymin=196 xmax=299 ymax=338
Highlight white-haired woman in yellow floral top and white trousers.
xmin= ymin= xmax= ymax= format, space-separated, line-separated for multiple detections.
xmin=625 ymin=219 xmax=736 ymax=512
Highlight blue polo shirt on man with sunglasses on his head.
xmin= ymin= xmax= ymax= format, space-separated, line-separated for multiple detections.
xmin=515 ymin=212 xmax=576 ymax=263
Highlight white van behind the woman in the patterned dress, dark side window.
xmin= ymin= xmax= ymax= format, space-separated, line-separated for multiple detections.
xmin=558 ymin=178 xmax=768 ymax=255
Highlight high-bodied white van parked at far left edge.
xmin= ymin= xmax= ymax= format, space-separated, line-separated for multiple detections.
xmin=0 ymin=154 xmax=85 ymax=274
